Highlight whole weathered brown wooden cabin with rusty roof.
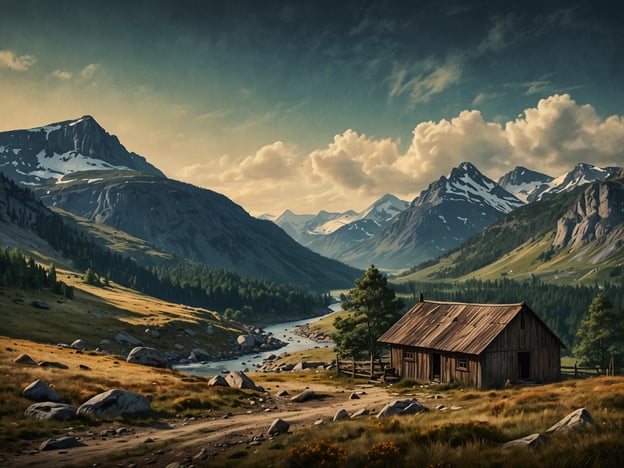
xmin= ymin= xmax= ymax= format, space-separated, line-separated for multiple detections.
xmin=378 ymin=301 xmax=565 ymax=388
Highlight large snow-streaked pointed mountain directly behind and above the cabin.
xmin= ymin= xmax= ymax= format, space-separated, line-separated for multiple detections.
xmin=340 ymin=162 xmax=523 ymax=270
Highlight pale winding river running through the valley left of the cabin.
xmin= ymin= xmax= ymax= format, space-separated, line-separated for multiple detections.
xmin=174 ymin=303 xmax=341 ymax=375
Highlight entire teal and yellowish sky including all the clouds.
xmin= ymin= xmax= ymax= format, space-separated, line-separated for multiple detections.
xmin=0 ymin=0 xmax=624 ymax=216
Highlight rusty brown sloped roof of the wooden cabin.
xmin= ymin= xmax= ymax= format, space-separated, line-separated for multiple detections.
xmin=378 ymin=301 xmax=532 ymax=354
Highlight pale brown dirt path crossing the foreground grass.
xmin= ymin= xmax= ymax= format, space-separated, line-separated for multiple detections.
xmin=5 ymin=383 xmax=392 ymax=467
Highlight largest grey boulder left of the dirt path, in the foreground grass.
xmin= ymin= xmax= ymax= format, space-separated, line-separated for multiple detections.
xmin=77 ymin=389 xmax=151 ymax=418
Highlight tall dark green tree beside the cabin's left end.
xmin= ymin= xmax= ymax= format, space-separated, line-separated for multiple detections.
xmin=333 ymin=265 xmax=404 ymax=371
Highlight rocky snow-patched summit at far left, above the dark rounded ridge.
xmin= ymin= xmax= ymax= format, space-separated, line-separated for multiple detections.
xmin=0 ymin=115 xmax=164 ymax=185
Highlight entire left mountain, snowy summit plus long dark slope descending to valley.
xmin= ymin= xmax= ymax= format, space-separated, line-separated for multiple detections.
xmin=0 ymin=116 xmax=359 ymax=290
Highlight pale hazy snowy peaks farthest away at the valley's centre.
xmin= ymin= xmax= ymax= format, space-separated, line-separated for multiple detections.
xmin=275 ymin=194 xmax=409 ymax=259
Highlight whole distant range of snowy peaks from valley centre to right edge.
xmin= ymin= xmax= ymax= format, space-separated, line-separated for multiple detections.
xmin=267 ymin=162 xmax=619 ymax=271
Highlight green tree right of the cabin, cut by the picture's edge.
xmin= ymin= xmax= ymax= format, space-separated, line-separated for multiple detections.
xmin=572 ymin=292 xmax=624 ymax=373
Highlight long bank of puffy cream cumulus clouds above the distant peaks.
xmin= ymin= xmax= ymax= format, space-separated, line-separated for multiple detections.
xmin=177 ymin=94 xmax=624 ymax=214
